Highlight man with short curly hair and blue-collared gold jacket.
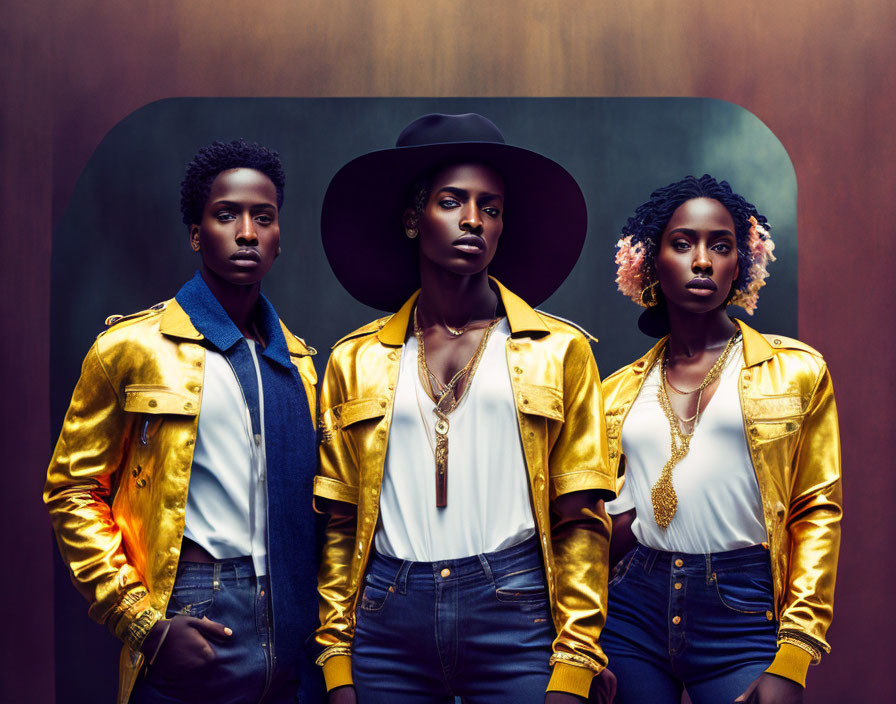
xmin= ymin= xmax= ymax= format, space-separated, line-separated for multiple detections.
xmin=44 ymin=140 xmax=324 ymax=704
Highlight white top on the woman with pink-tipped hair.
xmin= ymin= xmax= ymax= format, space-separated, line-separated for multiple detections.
xmin=607 ymin=342 xmax=768 ymax=554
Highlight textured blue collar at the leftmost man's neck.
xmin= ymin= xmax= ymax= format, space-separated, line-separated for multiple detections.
xmin=174 ymin=271 xmax=291 ymax=368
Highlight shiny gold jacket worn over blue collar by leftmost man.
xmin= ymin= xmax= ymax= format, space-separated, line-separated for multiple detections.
xmin=44 ymin=299 xmax=317 ymax=703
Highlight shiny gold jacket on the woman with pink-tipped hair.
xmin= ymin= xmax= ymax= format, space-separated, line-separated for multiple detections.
xmin=603 ymin=320 xmax=842 ymax=662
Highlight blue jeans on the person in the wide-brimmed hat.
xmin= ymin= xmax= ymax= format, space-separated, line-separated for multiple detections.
xmin=352 ymin=538 xmax=557 ymax=704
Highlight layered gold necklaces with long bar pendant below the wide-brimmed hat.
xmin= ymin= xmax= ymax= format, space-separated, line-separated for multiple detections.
xmin=414 ymin=308 xmax=501 ymax=508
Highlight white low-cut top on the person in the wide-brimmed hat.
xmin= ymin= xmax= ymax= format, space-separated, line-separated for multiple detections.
xmin=375 ymin=319 xmax=535 ymax=562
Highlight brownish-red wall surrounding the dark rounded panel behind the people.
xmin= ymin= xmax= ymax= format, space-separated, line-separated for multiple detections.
xmin=0 ymin=0 xmax=896 ymax=704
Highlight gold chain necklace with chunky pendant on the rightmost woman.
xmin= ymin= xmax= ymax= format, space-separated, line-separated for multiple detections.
xmin=650 ymin=332 xmax=739 ymax=530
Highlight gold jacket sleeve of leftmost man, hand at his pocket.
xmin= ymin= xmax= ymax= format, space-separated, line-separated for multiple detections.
xmin=44 ymin=343 xmax=161 ymax=650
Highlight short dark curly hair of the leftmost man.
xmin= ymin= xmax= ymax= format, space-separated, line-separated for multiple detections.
xmin=180 ymin=139 xmax=286 ymax=227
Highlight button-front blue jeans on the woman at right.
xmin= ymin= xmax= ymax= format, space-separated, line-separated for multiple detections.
xmin=600 ymin=545 xmax=778 ymax=704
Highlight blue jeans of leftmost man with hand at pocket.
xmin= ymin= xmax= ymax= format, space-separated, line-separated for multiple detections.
xmin=130 ymin=557 xmax=298 ymax=704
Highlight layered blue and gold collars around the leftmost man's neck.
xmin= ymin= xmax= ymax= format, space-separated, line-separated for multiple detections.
xmin=160 ymin=271 xmax=296 ymax=367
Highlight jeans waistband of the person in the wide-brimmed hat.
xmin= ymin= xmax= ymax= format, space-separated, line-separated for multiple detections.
xmin=368 ymin=536 xmax=542 ymax=592
